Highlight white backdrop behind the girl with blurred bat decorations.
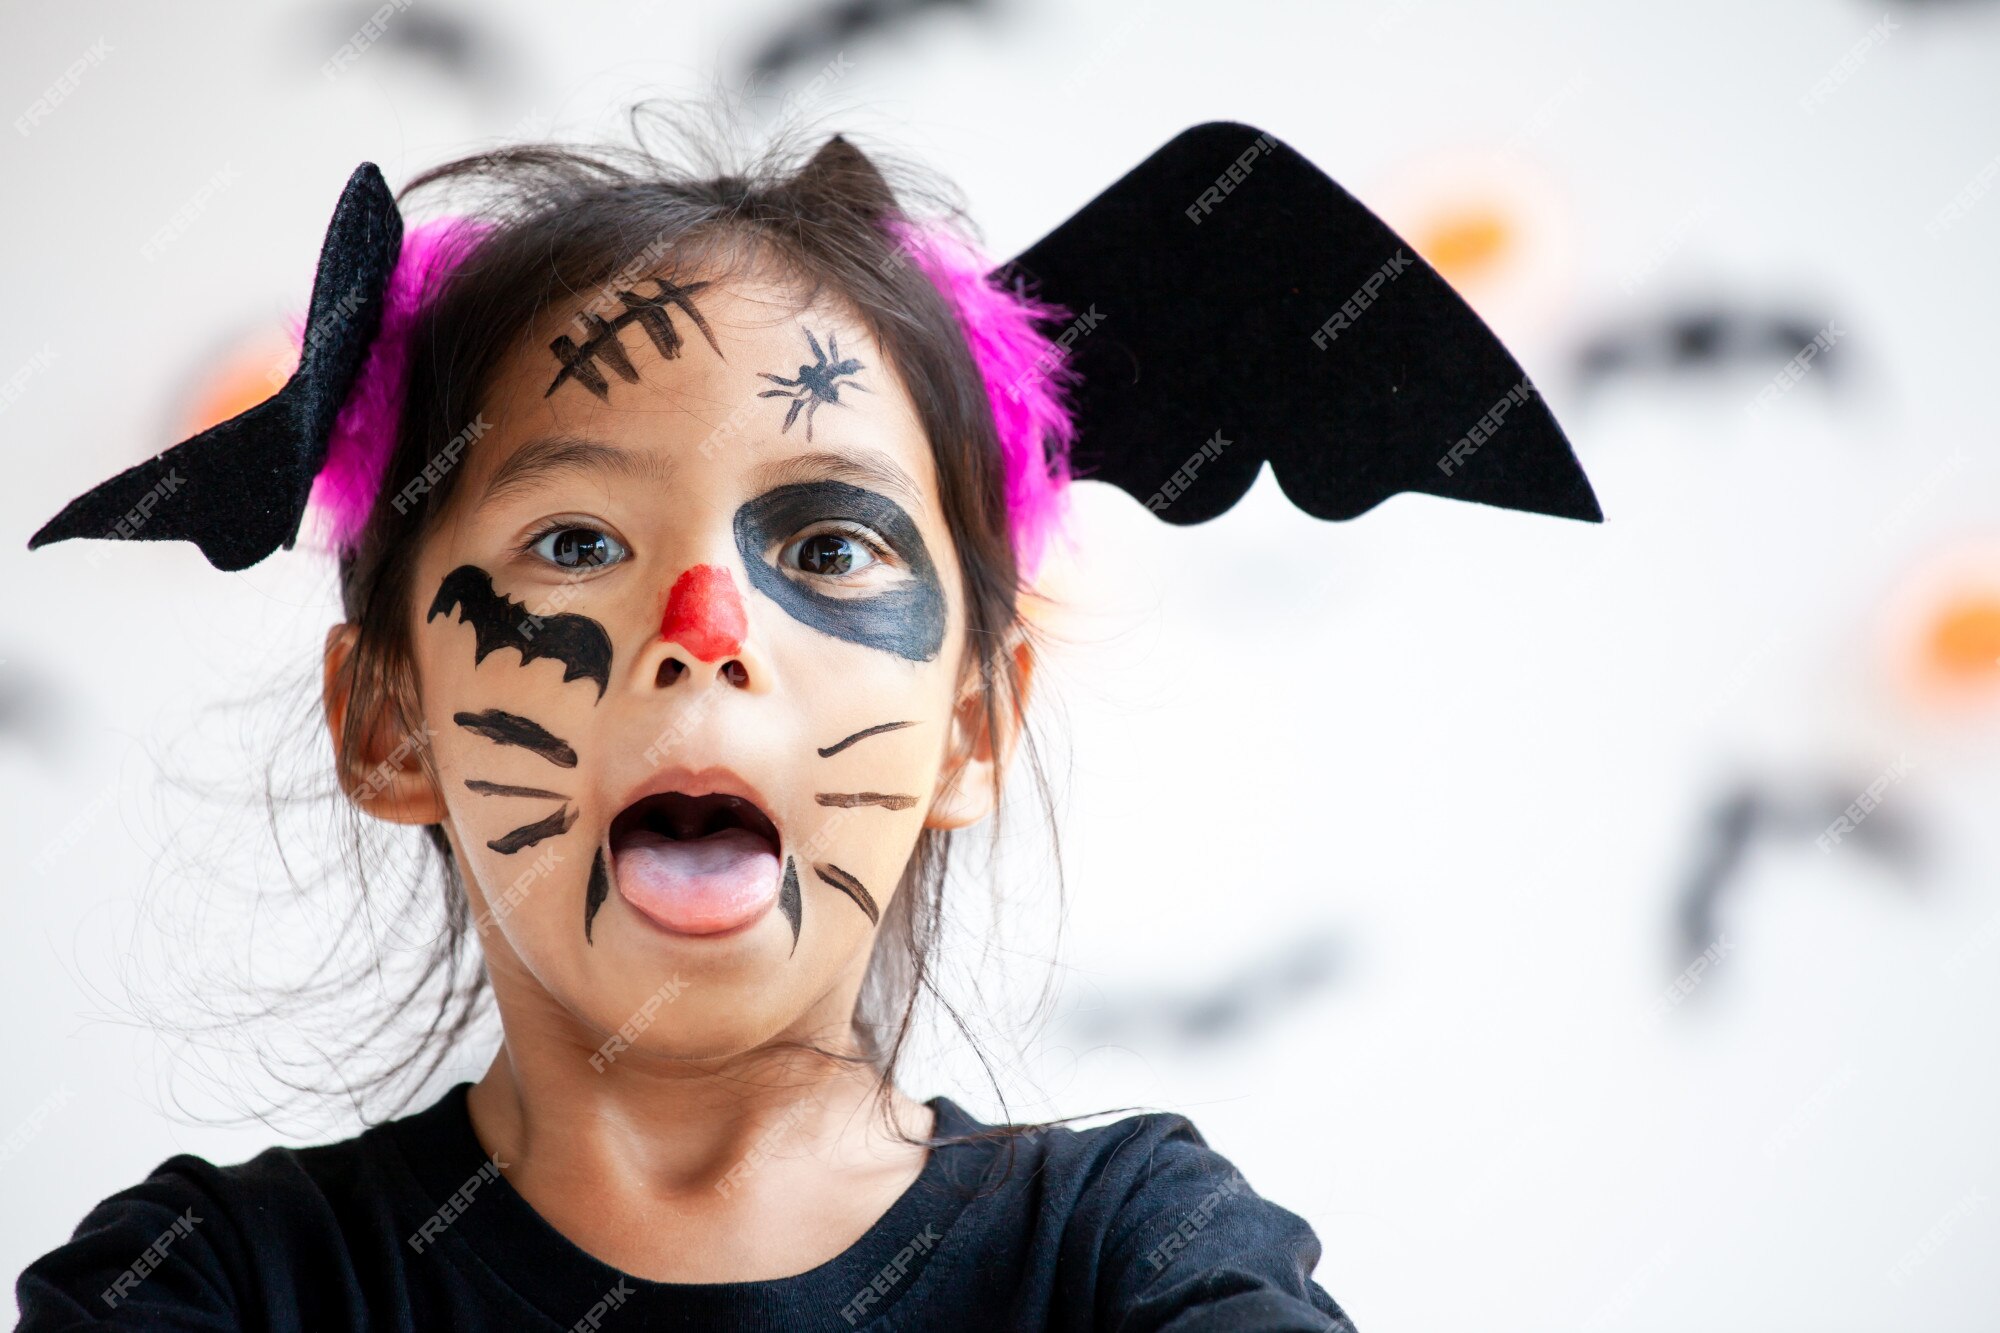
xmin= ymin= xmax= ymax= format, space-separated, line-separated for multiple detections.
xmin=0 ymin=0 xmax=2000 ymax=1333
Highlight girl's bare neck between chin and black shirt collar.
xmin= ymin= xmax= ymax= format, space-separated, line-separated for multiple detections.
xmin=468 ymin=1016 xmax=934 ymax=1283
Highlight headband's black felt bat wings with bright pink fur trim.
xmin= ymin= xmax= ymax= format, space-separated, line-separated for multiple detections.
xmin=28 ymin=122 xmax=1602 ymax=570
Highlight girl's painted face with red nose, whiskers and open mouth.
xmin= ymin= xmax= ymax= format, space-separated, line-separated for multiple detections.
xmin=394 ymin=276 xmax=986 ymax=1069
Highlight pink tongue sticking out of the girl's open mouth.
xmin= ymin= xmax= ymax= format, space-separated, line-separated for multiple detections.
xmin=612 ymin=829 xmax=778 ymax=935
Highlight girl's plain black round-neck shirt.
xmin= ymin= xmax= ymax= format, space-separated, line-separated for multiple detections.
xmin=16 ymin=1083 xmax=1352 ymax=1333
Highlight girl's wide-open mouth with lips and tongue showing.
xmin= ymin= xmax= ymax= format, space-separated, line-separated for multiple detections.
xmin=610 ymin=791 xmax=778 ymax=935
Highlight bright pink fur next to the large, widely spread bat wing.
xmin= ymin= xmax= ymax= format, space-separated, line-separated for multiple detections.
xmin=890 ymin=220 xmax=1076 ymax=578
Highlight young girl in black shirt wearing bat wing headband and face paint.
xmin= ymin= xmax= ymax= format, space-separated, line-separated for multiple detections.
xmin=3 ymin=109 xmax=1594 ymax=1329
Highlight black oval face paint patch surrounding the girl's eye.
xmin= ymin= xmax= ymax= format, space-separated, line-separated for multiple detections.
xmin=736 ymin=480 xmax=946 ymax=662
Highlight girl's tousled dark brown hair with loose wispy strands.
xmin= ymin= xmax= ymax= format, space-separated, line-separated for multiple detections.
xmin=316 ymin=108 xmax=1060 ymax=1111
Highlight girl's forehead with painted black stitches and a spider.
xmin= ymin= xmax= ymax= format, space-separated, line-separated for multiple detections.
xmin=466 ymin=272 xmax=936 ymax=508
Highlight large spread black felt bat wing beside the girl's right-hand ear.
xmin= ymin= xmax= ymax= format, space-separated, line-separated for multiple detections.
xmin=994 ymin=122 xmax=1602 ymax=524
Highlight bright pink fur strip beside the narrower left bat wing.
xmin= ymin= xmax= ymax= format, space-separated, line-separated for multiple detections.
xmin=296 ymin=218 xmax=488 ymax=550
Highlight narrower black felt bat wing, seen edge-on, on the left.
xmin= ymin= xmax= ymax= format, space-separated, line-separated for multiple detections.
xmin=28 ymin=162 xmax=402 ymax=570
